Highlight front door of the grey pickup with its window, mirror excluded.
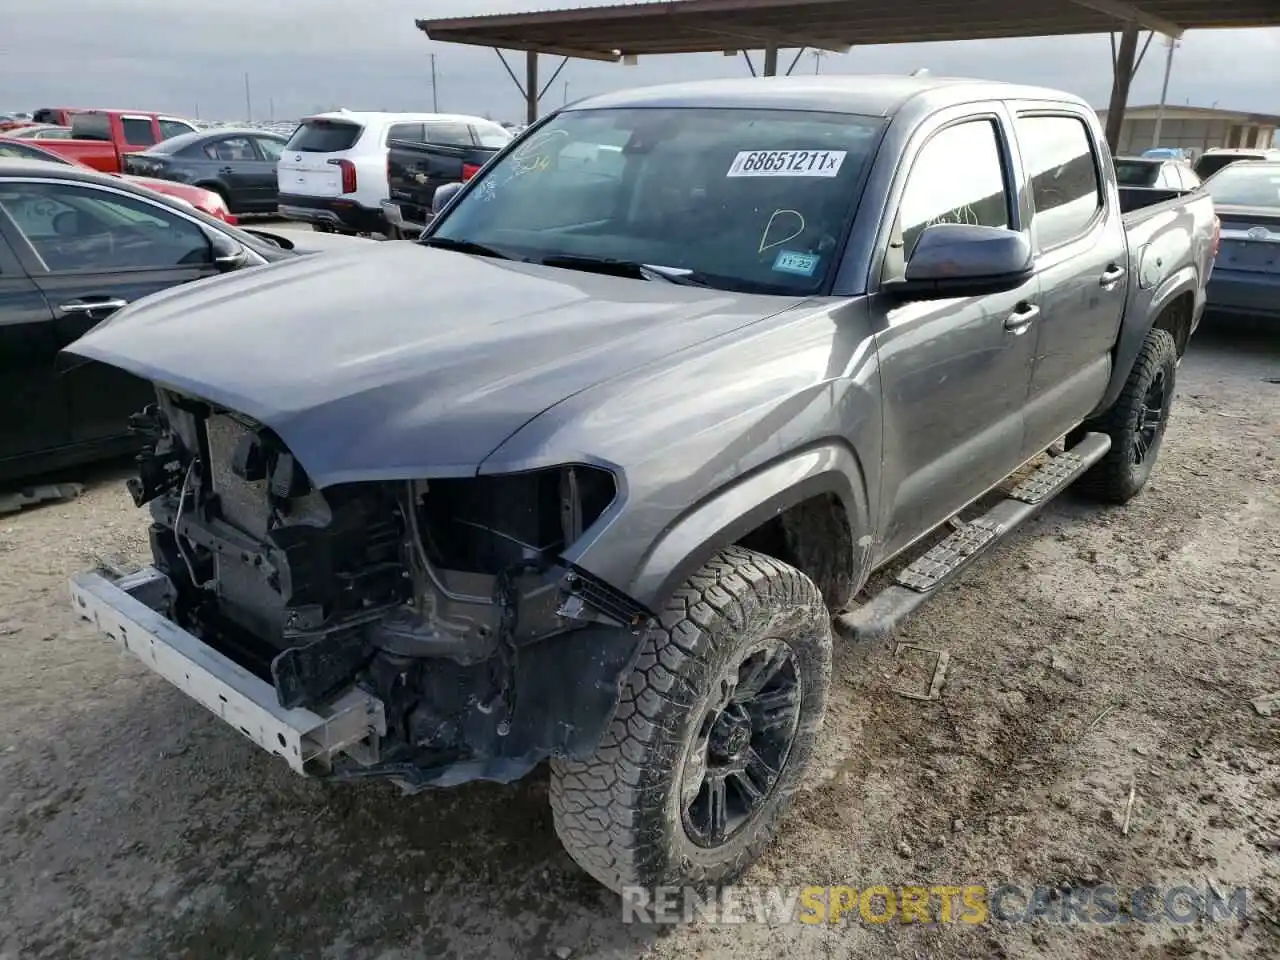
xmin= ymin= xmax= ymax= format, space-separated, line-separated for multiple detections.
xmin=872 ymin=105 xmax=1039 ymax=559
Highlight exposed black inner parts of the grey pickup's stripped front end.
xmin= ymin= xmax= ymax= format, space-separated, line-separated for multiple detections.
xmin=117 ymin=390 xmax=652 ymax=788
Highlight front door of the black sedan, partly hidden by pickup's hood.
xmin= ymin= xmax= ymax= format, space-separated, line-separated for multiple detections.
xmin=0 ymin=178 xmax=218 ymax=443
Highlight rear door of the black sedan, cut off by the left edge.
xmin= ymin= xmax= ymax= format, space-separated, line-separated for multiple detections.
xmin=0 ymin=222 xmax=70 ymax=471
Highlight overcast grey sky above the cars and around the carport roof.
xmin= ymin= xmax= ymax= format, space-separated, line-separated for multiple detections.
xmin=0 ymin=0 xmax=1280 ymax=120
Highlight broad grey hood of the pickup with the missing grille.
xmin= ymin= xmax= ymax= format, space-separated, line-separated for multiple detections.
xmin=67 ymin=242 xmax=795 ymax=486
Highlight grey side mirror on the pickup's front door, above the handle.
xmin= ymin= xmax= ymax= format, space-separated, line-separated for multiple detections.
xmin=884 ymin=223 xmax=1036 ymax=300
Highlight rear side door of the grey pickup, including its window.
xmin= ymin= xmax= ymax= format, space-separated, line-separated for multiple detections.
xmin=1015 ymin=110 xmax=1129 ymax=457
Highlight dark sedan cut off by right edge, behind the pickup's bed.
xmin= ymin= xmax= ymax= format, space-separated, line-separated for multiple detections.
xmin=1204 ymin=160 xmax=1280 ymax=319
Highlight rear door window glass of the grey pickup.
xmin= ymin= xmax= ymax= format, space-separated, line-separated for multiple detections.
xmin=1018 ymin=116 xmax=1102 ymax=248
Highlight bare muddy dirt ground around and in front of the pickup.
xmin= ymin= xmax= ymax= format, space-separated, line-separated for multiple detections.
xmin=0 ymin=329 xmax=1280 ymax=960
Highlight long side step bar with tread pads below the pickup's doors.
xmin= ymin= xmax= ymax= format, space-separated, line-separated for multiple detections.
xmin=835 ymin=433 xmax=1111 ymax=645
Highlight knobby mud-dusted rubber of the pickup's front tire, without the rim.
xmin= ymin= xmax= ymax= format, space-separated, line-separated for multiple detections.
xmin=550 ymin=547 xmax=831 ymax=892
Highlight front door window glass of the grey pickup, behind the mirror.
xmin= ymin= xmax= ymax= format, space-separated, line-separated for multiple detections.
xmin=899 ymin=120 xmax=1010 ymax=259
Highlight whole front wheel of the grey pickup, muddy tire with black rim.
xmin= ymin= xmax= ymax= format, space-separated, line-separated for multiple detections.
xmin=550 ymin=547 xmax=831 ymax=892
